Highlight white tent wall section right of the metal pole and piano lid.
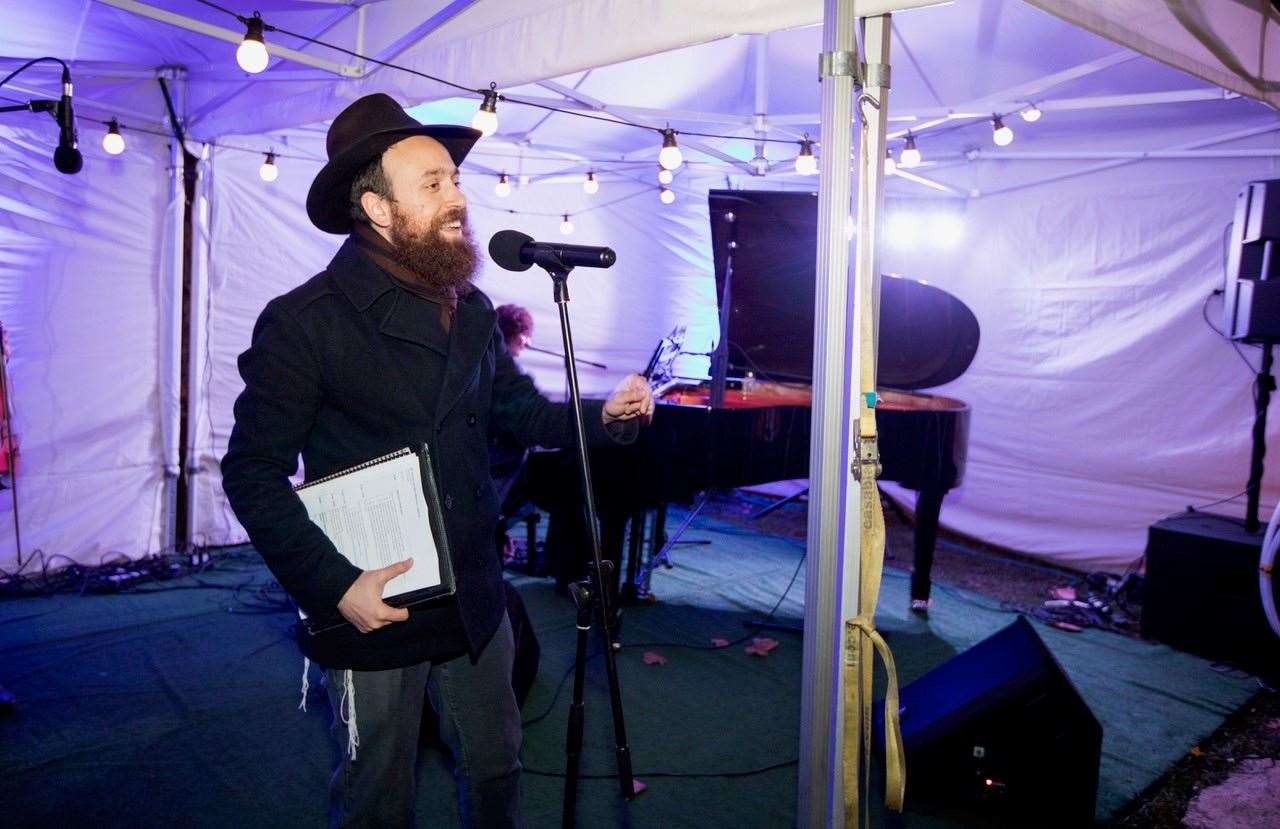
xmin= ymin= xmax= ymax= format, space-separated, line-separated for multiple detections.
xmin=884 ymin=150 xmax=1280 ymax=571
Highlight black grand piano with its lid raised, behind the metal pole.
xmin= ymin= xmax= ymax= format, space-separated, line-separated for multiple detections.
xmin=529 ymin=191 xmax=979 ymax=604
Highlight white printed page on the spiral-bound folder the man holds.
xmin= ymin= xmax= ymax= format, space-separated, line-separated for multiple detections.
xmin=298 ymin=452 xmax=440 ymax=599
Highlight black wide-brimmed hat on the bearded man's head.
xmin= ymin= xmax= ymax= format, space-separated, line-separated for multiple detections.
xmin=307 ymin=92 xmax=480 ymax=233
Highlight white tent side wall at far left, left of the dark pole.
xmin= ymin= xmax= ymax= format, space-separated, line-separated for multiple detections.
xmin=0 ymin=122 xmax=172 ymax=571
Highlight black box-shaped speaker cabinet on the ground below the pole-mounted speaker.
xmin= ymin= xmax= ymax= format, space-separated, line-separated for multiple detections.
xmin=1142 ymin=513 xmax=1280 ymax=681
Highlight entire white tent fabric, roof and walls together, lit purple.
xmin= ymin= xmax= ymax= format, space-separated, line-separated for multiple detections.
xmin=0 ymin=0 xmax=1280 ymax=569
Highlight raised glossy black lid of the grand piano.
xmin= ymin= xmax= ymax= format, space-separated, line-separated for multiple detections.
xmin=709 ymin=191 xmax=979 ymax=389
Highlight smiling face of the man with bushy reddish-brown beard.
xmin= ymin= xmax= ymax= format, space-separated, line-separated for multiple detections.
xmin=383 ymin=136 xmax=476 ymax=288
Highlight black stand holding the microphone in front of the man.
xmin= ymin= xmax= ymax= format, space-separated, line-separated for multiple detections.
xmin=538 ymin=257 xmax=635 ymax=829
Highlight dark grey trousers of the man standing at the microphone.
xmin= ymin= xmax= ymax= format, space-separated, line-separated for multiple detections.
xmin=325 ymin=617 xmax=522 ymax=829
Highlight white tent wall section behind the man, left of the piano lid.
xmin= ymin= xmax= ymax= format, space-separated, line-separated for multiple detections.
xmin=191 ymin=134 xmax=717 ymax=546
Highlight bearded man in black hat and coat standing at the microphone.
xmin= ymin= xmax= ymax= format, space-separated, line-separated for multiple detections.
xmin=223 ymin=95 xmax=653 ymax=826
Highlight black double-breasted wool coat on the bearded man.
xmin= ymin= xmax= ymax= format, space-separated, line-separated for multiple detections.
xmin=221 ymin=239 xmax=636 ymax=670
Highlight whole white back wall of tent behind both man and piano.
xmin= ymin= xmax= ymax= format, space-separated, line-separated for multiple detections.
xmin=195 ymin=122 xmax=1280 ymax=569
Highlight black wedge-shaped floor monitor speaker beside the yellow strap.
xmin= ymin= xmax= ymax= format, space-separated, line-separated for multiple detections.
xmin=874 ymin=617 xmax=1102 ymax=826
